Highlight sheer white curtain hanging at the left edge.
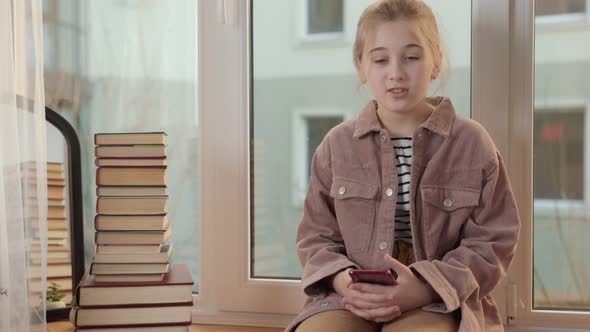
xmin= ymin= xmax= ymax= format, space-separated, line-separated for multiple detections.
xmin=0 ymin=0 xmax=47 ymax=332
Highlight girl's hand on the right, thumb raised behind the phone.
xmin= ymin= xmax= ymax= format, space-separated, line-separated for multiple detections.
xmin=345 ymin=254 xmax=439 ymax=320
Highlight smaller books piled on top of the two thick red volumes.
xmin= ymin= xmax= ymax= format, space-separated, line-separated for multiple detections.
xmin=90 ymin=133 xmax=172 ymax=282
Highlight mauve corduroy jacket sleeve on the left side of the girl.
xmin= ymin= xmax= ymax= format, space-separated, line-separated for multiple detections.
xmin=297 ymin=139 xmax=356 ymax=296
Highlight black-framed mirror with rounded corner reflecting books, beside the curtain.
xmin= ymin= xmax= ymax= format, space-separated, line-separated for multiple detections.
xmin=45 ymin=107 xmax=84 ymax=322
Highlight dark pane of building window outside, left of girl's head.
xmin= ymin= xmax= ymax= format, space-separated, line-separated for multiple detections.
xmin=306 ymin=0 xmax=343 ymax=34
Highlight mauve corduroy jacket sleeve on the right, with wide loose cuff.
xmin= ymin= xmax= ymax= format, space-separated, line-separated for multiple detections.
xmin=411 ymin=153 xmax=520 ymax=313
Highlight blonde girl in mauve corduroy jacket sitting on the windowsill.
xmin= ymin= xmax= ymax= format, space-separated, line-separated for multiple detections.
xmin=287 ymin=0 xmax=520 ymax=332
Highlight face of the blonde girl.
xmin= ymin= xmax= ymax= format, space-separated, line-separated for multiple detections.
xmin=359 ymin=19 xmax=434 ymax=113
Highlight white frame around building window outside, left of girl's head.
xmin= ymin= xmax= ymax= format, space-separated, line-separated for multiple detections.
xmin=294 ymin=0 xmax=347 ymax=44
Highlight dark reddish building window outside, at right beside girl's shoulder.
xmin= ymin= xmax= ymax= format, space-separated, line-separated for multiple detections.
xmin=534 ymin=109 xmax=585 ymax=200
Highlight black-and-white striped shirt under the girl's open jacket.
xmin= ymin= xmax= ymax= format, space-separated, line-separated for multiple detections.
xmin=391 ymin=137 xmax=412 ymax=244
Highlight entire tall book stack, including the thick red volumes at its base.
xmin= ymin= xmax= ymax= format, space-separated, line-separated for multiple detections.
xmin=70 ymin=132 xmax=193 ymax=332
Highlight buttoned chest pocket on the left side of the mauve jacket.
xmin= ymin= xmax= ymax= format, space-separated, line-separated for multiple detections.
xmin=330 ymin=178 xmax=379 ymax=255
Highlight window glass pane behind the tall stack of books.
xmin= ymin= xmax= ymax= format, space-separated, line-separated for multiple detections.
xmin=44 ymin=0 xmax=199 ymax=291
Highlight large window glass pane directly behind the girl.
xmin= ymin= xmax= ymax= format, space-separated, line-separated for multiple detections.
xmin=250 ymin=0 xmax=471 ymax=279
